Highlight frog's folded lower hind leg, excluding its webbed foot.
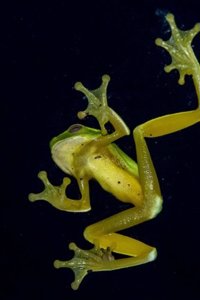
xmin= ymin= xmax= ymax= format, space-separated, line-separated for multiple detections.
xmin=84 ymin=207 xmax=157 ymax=264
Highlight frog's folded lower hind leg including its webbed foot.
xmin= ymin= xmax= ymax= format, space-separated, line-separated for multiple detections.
xmin=54 ymin=207 xmax=157 ymax=290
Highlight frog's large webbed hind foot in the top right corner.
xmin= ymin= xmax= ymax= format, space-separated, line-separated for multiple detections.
xmin=155 ymin=14 xmax=200 ymax=85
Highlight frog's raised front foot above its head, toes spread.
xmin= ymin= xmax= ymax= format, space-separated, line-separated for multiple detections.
xmin=74 ymin=75 xmax=110 ymax=135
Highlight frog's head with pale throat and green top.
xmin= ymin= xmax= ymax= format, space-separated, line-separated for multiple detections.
xmin=50 ymin=124 xmax=101 ymax=175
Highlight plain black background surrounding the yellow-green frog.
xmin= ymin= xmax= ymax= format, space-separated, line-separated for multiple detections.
xmin=0 ymin=0 xmax=200 ymax=300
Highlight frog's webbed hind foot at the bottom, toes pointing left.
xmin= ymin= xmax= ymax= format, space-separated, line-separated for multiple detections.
xmin=54 ymin=243 xmax=114 ymax=290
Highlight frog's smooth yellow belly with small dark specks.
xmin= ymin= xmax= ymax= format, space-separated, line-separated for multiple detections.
xmin=88 ymin=158 xmax=143 ymax=205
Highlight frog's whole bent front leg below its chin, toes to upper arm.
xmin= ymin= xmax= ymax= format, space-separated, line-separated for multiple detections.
xmin=29 ymin=171 xmax=91 ymax=212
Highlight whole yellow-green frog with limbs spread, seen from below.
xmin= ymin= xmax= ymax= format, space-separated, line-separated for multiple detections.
xmin=29 ymin=13 xmax=200 ymax=290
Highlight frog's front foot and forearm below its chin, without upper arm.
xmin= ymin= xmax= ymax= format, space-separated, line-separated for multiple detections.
xmin=28 ymin=171 xmax=90 ymax=212
